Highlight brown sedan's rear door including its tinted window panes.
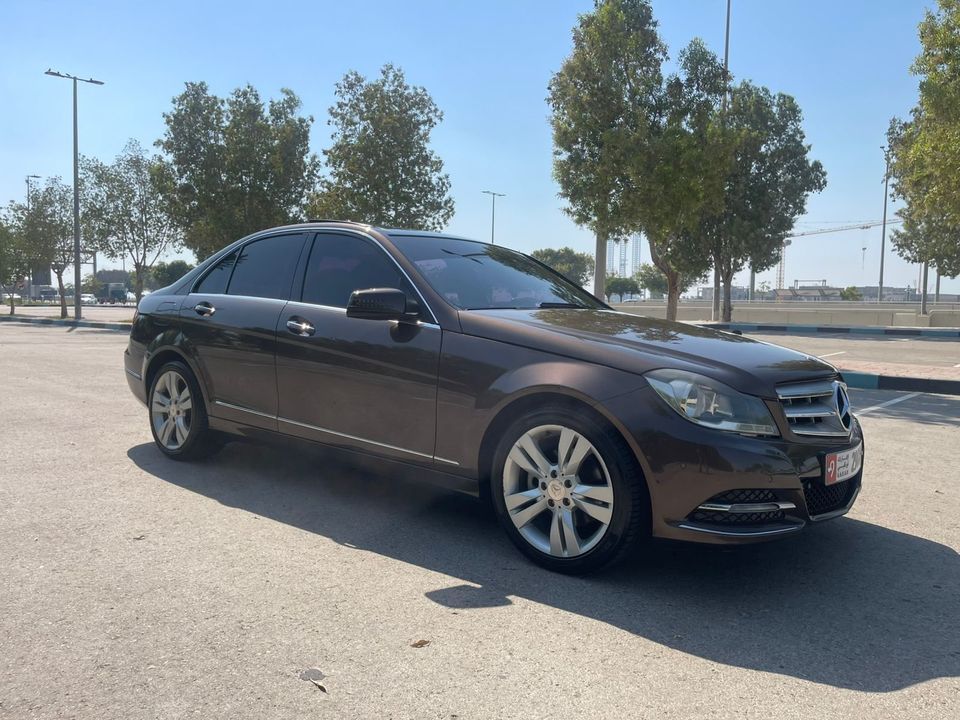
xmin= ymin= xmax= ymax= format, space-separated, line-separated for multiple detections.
xmin=180 ymin=233 xmax=305 ymax=430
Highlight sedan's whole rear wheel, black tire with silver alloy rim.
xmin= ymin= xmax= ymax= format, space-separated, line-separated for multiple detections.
xmin=147 ymin=361 xmax=223 ymax=460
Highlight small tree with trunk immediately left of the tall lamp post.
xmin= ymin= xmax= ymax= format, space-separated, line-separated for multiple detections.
xmin=10 ymin=177 xmax=74 ymax=318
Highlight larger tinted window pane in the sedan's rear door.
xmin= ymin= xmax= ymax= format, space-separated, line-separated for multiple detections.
xmin=227 ymin=235 xmax=303 ymax=300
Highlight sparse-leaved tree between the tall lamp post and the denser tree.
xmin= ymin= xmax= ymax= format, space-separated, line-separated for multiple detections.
xmin=82 ymin=140 xmax=181 ymax=302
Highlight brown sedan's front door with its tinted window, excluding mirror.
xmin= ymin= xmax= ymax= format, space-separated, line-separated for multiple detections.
xmin=277 ymin=233 xmax=441 ymax=462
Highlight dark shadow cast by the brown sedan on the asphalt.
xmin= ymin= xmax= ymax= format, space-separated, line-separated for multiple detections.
xmin=127 ymin=442 xmax=960 ymax=692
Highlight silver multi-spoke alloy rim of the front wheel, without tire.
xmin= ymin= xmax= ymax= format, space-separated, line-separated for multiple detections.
xmin=503 ymin=425 xmax=613 ymax=558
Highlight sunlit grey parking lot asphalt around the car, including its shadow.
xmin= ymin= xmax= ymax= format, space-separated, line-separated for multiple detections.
xmin=0 ymin=325 xmax=960 ymax=720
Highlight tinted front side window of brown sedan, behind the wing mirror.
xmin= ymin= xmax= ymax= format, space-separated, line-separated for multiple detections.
xmin=303 ymin=235 xmax=415 ymax=308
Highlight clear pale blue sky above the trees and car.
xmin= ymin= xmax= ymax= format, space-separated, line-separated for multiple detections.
xmin=0 ymin=0 xmax=944 ymax=292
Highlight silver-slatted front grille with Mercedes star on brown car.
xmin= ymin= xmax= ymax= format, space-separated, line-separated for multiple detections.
xmin=777 ymin=380 xmax=853 ymax=438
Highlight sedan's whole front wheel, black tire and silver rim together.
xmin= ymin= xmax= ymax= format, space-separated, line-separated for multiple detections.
xmin=490 ymin=406 xmax=650 ymax=574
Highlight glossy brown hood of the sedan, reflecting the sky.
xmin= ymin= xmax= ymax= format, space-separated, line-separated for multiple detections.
xmin=460 ymin=308 xmax=837 ymax=399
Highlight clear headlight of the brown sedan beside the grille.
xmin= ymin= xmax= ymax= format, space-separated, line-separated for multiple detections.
xmin=644 ymin=369 xmax=780 ymax=435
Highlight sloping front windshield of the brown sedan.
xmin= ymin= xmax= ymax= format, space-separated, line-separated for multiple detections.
xmin=390 ymin=235 xmax=605 ymax=310
